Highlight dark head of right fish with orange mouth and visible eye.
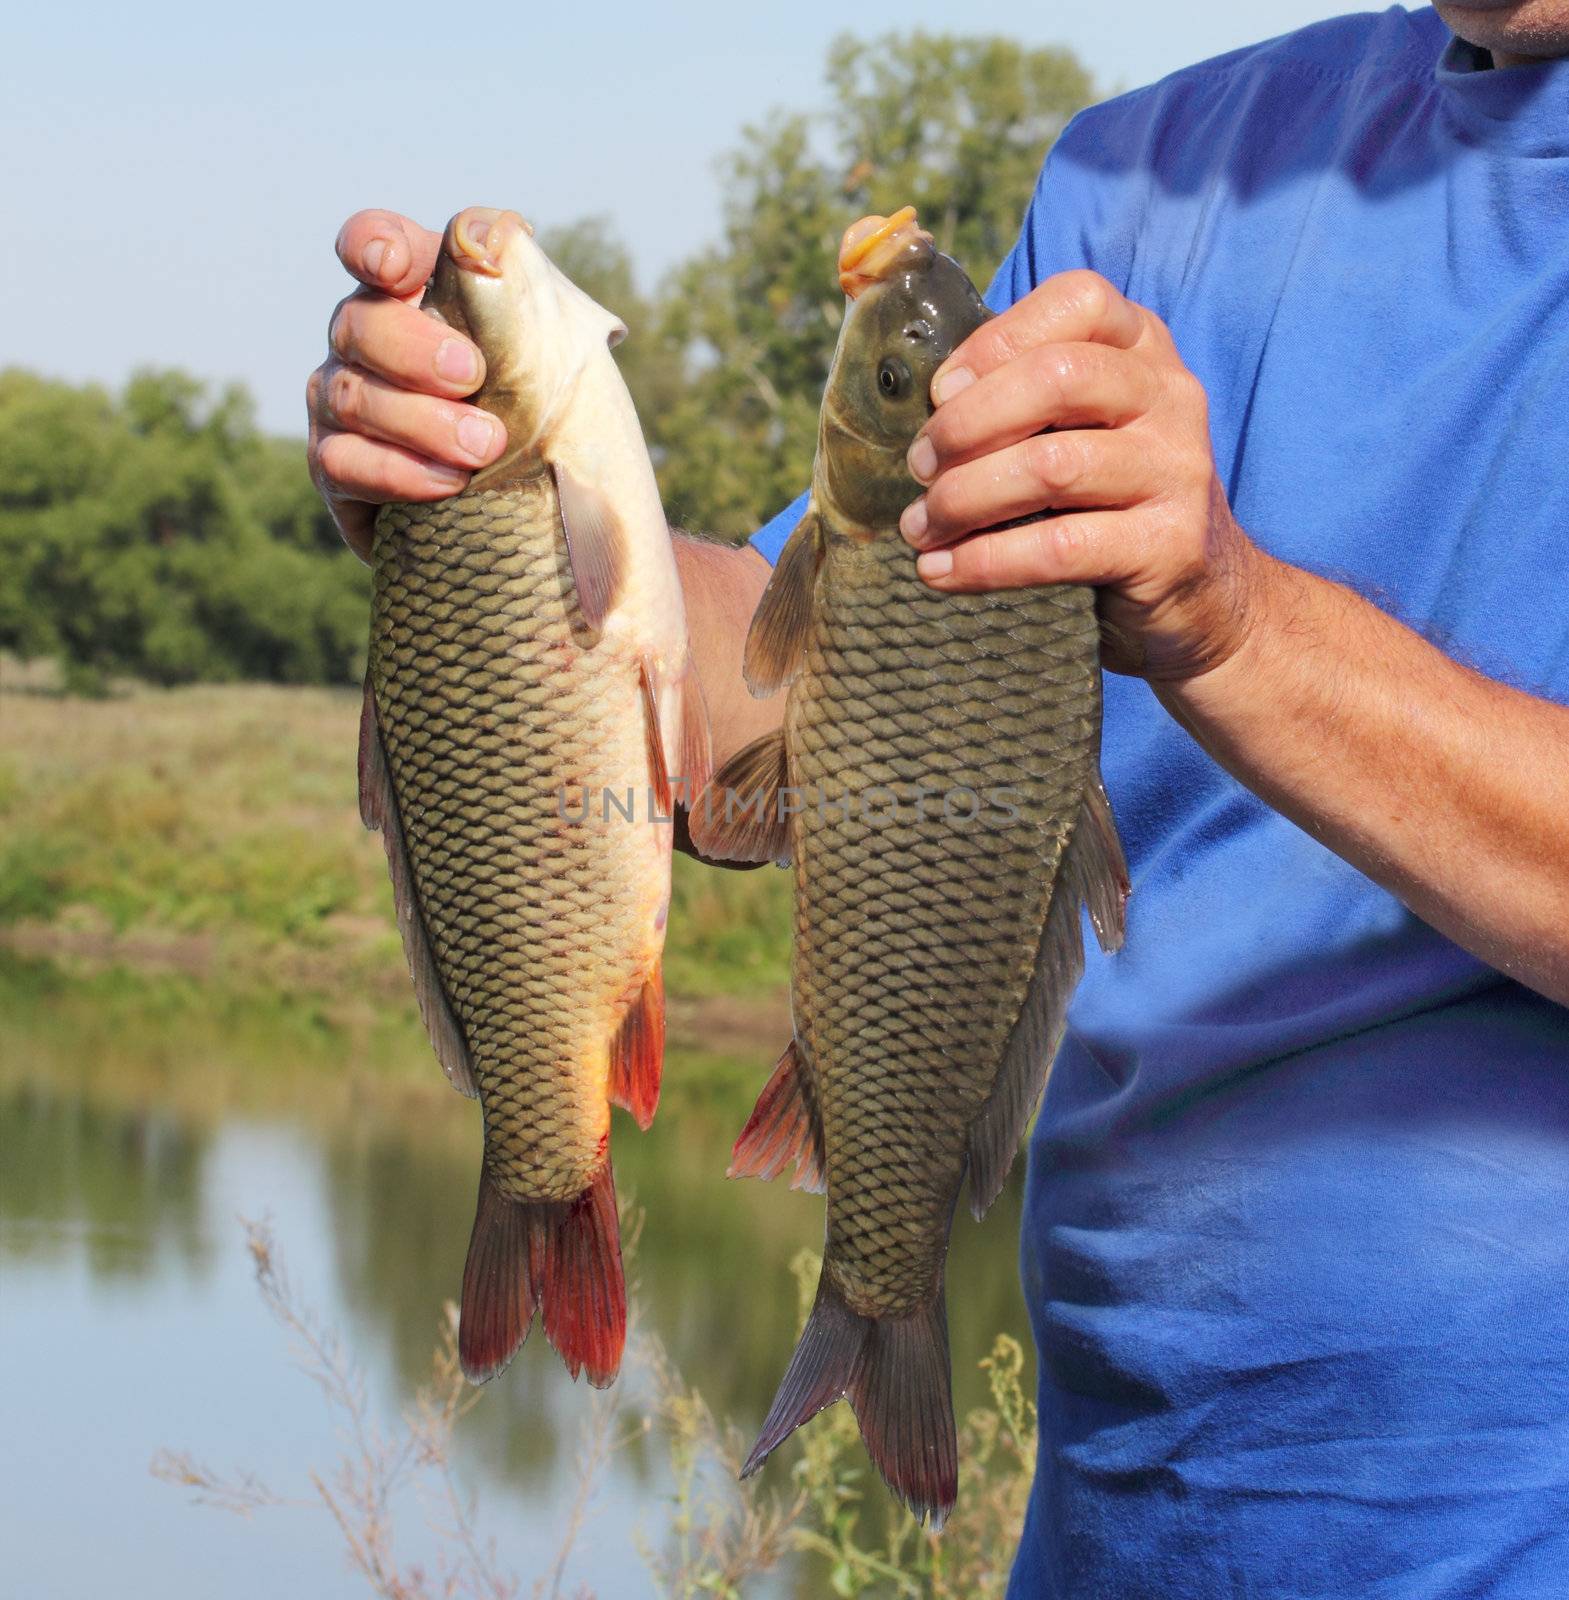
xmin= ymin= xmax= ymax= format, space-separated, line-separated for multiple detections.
xmin=816 ymin=206 xmax=992 ymax=539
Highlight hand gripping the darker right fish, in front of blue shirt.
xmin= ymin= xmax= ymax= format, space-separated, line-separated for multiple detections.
xmin=900 ymin=272 xmax=1270 ymax=680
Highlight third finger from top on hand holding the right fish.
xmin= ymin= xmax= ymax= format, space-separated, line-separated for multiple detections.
xmin=899 ymin=429 xmax=1160 ymax=550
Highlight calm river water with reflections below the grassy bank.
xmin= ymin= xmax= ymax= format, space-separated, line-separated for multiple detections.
xmin=0 ymin=963 xmax=1025 ymax=1600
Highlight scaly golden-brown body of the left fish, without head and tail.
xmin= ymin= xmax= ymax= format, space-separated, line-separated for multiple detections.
xmin=371 ymin=475 xmax=659 ymax=1200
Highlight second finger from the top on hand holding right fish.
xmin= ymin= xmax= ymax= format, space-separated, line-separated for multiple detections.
xmin=908 ymin=344 xmax=1160 ymax=483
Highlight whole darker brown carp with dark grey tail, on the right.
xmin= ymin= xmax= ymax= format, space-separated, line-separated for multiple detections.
xmin=694 ymin=208 xmax=1128 ymax=1526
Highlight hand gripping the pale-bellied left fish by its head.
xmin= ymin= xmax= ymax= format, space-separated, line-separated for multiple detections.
xmin=305 ymin=211 xmax=507 ymax=560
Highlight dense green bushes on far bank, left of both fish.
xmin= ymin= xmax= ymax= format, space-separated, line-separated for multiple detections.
xmin=0 ymin=370 xmax=368 ymax=688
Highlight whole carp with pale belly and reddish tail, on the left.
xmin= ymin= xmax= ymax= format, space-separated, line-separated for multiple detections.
xmin=360 ymin=206 xmax=709 ymax=1384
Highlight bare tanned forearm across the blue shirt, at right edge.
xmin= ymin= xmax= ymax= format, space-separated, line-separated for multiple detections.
xmin=1153 ymin=552 xmax=1569 ymax=1003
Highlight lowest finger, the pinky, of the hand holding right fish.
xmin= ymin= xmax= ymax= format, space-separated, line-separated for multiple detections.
xmin=915 ymin=510 xmax=1137 ymax=594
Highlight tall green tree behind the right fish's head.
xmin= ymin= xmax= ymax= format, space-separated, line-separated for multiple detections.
xmin=645 ymin=34 xmax=1094 ymax=536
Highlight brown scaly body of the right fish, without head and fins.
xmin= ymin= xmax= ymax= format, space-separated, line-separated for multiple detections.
xmin=787 ymin=541 xmax=1100 ymax=1317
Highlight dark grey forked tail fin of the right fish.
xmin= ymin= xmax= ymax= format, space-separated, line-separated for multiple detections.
xmin=741 ymin=1274 xmax=958 ymax=1530
